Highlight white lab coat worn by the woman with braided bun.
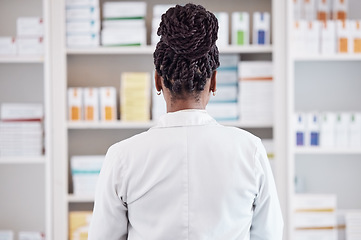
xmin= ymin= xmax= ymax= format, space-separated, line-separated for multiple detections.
xmin=88 ymin=110 xmax=283 ymax=240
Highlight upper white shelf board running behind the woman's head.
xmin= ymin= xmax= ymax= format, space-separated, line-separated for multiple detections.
xmin=67 ymin=45 xmax=272 ymax=55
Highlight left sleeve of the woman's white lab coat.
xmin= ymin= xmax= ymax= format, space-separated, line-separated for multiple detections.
xmin=88 ymin=144 xmax=128 ymax=240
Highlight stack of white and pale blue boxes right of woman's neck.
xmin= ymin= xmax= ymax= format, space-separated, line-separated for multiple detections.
xmin=207 ymin=54 xmax=239 ymax=122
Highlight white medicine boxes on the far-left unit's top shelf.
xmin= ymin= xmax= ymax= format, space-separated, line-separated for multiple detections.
xmin=0 ymin=17 xmax=44 ymax=56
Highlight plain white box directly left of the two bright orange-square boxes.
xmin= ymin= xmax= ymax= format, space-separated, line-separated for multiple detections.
xmin=320 ymin=20 xmax=337 ymax=54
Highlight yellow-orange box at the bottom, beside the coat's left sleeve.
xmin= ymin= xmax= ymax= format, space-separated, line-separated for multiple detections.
xmin=69 ymin=211 xmax=93 ymax=240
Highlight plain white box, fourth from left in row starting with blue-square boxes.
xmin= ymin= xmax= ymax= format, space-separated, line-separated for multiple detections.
xmin=335 ymin=113 xmax=351 ymax=147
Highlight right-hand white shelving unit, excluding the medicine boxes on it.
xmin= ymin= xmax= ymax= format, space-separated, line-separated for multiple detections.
xmin=286 ymin=0 xmax=361 ymax=239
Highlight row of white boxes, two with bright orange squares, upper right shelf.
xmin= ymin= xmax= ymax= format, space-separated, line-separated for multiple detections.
xmin=293 ymin=20 xmax=361 ymax=54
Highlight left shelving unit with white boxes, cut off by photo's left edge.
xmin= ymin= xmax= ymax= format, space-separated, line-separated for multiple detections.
xmin=0 ymin=0 xmax=52 ymax=240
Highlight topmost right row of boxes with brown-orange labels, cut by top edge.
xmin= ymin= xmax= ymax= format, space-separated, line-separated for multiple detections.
xmin=292 ymin=0 xmax=348 ymax=21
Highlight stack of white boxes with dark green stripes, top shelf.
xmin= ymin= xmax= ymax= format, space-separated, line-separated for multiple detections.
xmin=101 ymin=2 xmax=147 ymax=46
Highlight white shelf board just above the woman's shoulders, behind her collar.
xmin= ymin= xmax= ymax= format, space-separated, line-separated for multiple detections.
xmin=68 ymin=121 xmax=273 ymax=129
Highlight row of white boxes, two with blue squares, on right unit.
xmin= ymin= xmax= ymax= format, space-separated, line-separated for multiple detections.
xmin=294 ymin=112 xmax=361 ymax=147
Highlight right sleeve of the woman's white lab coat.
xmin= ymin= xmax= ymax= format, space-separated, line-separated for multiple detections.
xmin=250 ymin=141 xmax=283 ymax=240
